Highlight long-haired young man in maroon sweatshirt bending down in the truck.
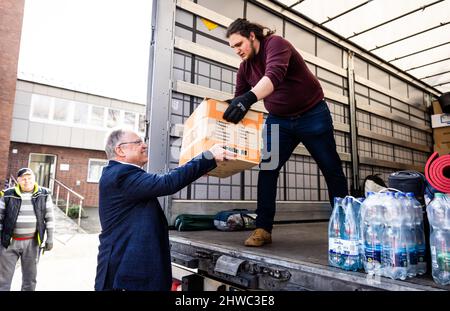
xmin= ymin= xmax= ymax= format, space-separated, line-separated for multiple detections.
xmin=223 ymin=18 xmax=348 ymax=246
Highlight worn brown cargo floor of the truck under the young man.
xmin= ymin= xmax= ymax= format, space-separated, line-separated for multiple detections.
xmin=169 ymin=222 xmax=450 ymax=290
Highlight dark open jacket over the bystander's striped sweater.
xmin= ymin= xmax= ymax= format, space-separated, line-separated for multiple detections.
xmin=1 ymin=184 xmax=50 ymax=248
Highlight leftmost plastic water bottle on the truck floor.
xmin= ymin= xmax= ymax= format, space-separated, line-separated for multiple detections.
xmin=328 ymin=198 xmax=344 ymax=268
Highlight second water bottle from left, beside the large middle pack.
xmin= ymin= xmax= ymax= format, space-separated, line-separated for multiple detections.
xmin=342 ymin=198 xmax=360 ymax=271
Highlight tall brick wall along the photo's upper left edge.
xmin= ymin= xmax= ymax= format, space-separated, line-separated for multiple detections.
xmin=0 ymin=0 xmax=24 ymax=181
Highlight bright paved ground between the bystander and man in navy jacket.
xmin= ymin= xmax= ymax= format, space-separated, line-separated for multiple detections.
xmin=11 ymin=209 xmax=100 ymax=291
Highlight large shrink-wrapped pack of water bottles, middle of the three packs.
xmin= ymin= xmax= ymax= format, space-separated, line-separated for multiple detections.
xmin=361 ymin=192 xmax=426 ymax=280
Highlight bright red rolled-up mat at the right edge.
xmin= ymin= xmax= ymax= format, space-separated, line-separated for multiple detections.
xmin=425 ymin=152 xmax=450 ymax=193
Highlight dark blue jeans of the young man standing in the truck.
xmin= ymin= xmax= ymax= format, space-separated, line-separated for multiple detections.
xmin=256 ymin=100 xmax=348 ymax=232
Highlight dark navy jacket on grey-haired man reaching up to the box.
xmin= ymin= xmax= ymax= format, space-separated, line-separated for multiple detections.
xmin=95 ymin=151 xmax=216 ymax=290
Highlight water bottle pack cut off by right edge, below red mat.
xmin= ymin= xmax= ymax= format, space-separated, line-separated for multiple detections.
xmin=427 ymin=193 xmax=450 ymax=285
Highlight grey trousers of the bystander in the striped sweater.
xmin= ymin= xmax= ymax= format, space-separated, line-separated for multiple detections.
xmin=0 ymin=239 xmax=39 ymax=291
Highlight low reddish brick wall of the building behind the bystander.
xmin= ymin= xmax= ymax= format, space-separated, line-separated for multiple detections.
xmin=8 ymin=142 xmax=106 ymax=206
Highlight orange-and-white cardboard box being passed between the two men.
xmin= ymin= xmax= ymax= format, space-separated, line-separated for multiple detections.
xmin=179 ymin=99 xmax=263 ymax=178
